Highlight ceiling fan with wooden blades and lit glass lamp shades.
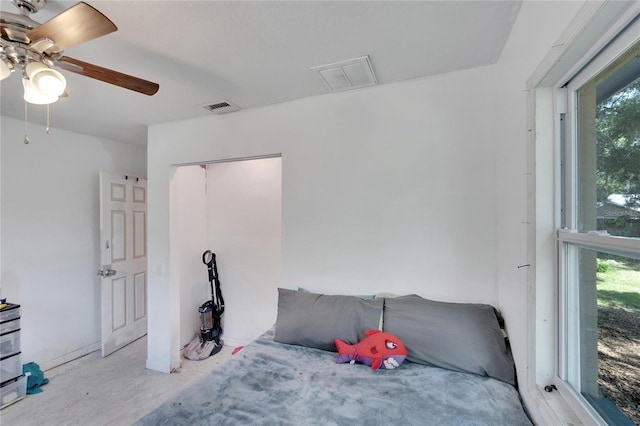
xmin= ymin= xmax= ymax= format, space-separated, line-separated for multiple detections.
xmin=0 ymin=0 xmax=160 ymax=105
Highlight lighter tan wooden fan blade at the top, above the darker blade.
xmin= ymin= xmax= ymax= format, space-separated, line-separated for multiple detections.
xmin=27 ymin=2 xmax=118 ymax=53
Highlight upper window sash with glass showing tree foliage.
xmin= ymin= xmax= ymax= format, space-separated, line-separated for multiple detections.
xmin=576 ymin=45 xmax=640 ymax=237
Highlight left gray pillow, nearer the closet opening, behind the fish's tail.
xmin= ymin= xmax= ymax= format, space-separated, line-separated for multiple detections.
xmin=274 ymin=288 xmax=384 ymax=352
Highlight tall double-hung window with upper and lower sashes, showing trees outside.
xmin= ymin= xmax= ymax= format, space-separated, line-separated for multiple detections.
xmin=558 ymin=35 xmax=640 ymax=425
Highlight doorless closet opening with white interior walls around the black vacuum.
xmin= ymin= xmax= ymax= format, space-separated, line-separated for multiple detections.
xmin=169 ymin=155 xmax=282 ymax=347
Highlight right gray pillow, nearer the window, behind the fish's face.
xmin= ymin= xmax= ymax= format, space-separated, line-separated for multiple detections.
xmin=384 ymin=295 xmax=515 ymax=385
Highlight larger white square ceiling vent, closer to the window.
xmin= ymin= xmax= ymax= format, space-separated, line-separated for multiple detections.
xmin=311 ymin=56 xmax=378 ymax=92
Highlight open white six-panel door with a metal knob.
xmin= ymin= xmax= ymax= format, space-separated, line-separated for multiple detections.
xmin=98 ymin=173 xmax=147 ymax=356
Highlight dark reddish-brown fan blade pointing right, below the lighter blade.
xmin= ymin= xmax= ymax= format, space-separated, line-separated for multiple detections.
xmin=57 ymin=56 xmax=160 ymax=96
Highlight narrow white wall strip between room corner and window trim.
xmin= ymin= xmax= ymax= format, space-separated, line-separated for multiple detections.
xmin=494 ymin=1 xmax=584 ymax=381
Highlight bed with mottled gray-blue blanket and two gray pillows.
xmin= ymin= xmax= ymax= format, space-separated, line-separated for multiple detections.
xmin=137 ymin=289 xmax=531 ymax=426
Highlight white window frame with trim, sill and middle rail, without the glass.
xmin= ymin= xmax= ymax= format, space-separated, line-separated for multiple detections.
xmin=521 ymin=1 xmax=640 ymax=425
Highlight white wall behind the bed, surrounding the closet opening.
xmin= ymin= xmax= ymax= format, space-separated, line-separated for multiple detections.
xmin=147 ymin=67 xmax=498 ymax=371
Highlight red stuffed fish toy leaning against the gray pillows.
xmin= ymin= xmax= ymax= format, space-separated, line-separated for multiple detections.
xmin=333 ymin=330 xmax=407 ymax=370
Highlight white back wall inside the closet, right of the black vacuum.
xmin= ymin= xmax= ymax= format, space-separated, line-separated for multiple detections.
xmin=201 ymin=158 xmax=282 ymax=345
